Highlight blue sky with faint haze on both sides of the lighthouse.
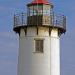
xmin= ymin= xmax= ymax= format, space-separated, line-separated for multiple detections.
xmin=0 ymin=0 xmax=75 ymax=75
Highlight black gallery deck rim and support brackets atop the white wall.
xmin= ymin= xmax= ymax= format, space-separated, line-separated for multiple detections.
xmin=13 ymin=25 xmax=66 ymax=35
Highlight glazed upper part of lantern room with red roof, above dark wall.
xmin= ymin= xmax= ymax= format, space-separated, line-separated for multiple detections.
xmin=27 ymin=0 xmax=53 ymax=16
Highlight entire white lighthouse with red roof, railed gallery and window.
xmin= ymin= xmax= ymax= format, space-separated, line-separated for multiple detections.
xmin=13 ymin=0 xmax=66 ymax=75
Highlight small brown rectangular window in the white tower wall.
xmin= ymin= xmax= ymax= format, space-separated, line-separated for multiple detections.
xmin=35 ymin=39 xmax=43 ymax=53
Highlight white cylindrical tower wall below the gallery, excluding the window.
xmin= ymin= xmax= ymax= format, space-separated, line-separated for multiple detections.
xmin=18 ymin=27 xmax=60 ymax=75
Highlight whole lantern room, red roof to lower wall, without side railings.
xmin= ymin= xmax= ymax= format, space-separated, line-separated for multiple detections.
xmin=27 ymin=0 xmax=53 ymax=25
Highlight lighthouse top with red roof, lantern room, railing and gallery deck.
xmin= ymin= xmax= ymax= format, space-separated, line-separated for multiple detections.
xmin=13 ymin=0 xmax=66 ymax=33
